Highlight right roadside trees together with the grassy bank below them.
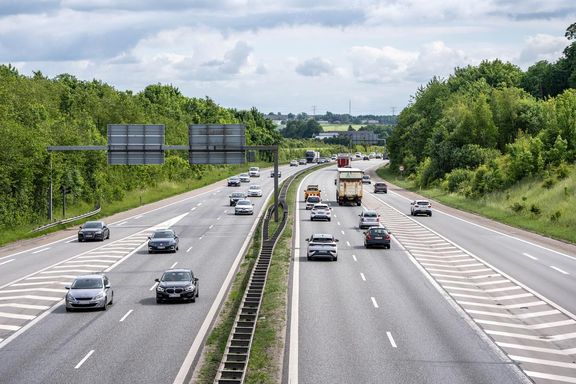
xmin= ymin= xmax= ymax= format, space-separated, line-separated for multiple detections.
xmin=387 ymin=23 xmax=576 ymax=246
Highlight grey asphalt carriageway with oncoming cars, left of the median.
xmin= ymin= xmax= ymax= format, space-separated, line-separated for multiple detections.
xmin=0 ymin=166 xmax=303 ymax=384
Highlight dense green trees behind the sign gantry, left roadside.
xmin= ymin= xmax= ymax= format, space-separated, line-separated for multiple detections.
xmin=0 ymin=65 xmax=281 ymax=228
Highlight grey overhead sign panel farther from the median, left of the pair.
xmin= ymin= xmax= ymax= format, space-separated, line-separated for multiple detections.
xmin=108 ymin=124 xmax=164 ymax=165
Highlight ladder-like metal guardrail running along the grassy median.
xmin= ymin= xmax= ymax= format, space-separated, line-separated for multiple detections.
xmin=214 ymin=172 xmax=300 ymax=384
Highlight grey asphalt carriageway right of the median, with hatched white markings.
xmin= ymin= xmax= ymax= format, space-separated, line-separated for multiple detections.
xmin=284 ymin=160 xmax=576 ymax=383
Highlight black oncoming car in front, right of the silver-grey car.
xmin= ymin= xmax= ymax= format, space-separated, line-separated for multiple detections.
xmin=155 ymin=268 xmax=198 ymax=303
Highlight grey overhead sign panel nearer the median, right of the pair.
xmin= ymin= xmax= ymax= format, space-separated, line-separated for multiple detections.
xmin=189 ymin=124 xmax=246 ymax=164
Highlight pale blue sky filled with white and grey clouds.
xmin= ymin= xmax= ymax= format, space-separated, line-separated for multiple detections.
xmin=0 ymin=0 xmax=576 ymax=115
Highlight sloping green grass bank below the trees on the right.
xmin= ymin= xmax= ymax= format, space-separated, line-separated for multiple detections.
xmin=377 ymin=166 xmax=576 ymax=243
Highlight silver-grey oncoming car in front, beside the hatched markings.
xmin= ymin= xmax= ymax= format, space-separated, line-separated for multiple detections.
xmin=65 ymin=273 xmax=114 ymax=312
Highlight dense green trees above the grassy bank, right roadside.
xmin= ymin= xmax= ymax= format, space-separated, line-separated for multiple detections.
xmin=387 ymin=23 xmax=576 ymax=201
